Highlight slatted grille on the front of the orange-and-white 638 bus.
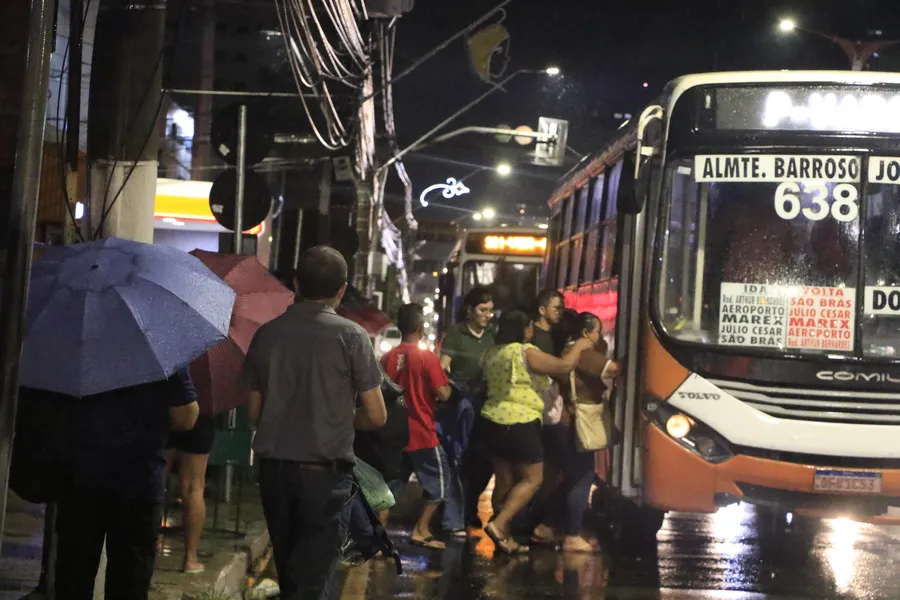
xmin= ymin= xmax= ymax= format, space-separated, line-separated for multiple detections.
xmin=709 ymin=379 xmax=900 ymax=425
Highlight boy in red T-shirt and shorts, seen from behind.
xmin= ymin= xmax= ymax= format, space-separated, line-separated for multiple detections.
xmin=382 ymin=304 xmax=451 ymax=550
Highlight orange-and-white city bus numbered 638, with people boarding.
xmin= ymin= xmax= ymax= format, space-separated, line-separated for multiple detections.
xmin=542 ymin=71 xmax=900 ymax=540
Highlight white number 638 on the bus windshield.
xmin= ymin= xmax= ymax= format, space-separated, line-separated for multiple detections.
xmin=775 ymin=181 xmax=859 ymax=223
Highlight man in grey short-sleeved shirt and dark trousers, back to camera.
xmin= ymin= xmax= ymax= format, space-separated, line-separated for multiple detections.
xmin=244 ymin=246 xmax=387 ymax=600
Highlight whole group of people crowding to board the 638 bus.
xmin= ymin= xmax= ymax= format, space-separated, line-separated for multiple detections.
xmin=342 ymin=288 xmax=619 ymax=554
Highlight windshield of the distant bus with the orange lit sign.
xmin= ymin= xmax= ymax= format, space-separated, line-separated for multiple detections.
xmin=462 ymin=260 xmax=541 ymax=314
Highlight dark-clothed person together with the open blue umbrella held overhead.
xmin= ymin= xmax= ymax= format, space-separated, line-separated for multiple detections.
xmin=10 ymin=238 xmax=235 ymax=600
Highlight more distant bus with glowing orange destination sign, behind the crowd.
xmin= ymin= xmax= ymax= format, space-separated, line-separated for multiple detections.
xmin=435 ymin=227 xmax=547 ymax=339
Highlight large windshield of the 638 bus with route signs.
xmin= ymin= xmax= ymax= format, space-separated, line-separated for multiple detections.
xmin=656 ymin=155 xmax=900 ymax=357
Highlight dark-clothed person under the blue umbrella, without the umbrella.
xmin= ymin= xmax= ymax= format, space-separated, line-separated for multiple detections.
xmin=45 ymin=371 xmax=199 ymax=600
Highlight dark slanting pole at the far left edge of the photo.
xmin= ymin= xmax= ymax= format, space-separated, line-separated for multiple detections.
xmin=0 ymin=0 xmax=55 ymax=552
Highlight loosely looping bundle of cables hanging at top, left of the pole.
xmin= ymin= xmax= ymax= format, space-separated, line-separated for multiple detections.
xmin=275 ymin=0 xmax=374 ymax=154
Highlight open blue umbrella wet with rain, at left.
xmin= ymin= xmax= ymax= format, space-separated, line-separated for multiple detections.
xmin=20 ymin=238 xmax=235 ymax=397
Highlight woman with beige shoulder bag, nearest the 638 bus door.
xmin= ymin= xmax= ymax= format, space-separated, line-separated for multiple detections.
xmin=539 ymin=312 xmax=621 ymax=552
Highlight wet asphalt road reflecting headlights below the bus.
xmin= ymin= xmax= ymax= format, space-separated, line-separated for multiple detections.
xmin=331 ymin=506 xmax=900 ymax=600
